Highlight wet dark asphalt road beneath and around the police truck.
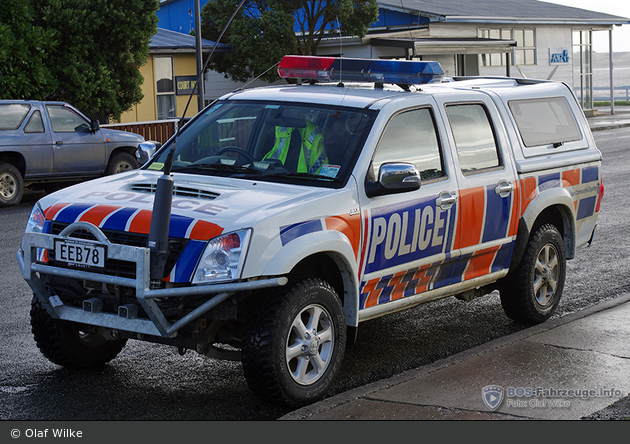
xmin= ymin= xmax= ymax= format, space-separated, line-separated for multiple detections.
xmin=0 ymin=129 xmax=630 ymax=420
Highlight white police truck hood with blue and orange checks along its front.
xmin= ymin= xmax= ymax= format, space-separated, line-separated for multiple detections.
xmin=40 ymin=170 xmax=330 ymax=240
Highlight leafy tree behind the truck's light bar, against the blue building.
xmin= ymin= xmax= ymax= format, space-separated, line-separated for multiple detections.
xmin=201 ymin=0 xmax=378 ymax=82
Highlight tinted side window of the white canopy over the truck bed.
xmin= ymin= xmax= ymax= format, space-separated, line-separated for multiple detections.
xmin=509 ymin=97 xmax=582 ymax=147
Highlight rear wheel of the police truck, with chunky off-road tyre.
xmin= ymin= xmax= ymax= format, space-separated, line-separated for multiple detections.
xmin=500 ymin=224 xmax=566 ymax=324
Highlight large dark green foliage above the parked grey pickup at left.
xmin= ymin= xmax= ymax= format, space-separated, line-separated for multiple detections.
xmin=0 ymin=0 xmax=158 ymax=118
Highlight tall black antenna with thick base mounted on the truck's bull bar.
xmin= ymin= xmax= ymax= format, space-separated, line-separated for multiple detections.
xmin=147 ymin=0 xmax=245 ymax=287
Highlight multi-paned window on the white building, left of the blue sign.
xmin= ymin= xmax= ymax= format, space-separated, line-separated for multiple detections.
xmin=479 ymin=28 xmax=536 ymax=66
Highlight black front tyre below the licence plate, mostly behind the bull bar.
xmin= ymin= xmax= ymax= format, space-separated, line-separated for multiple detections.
xmin=30 ymin=297 xmax=127 ymax=369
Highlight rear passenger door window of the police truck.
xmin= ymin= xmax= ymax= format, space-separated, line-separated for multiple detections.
xmin=446 ymin=103 xmax=501 ymax=173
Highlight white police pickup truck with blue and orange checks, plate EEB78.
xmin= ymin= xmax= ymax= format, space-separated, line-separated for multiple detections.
xmin=17 ymin=56 xmax=604 ymax=406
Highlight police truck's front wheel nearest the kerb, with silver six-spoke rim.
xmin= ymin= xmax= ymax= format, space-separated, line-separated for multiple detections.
xmin=243 ymin=278 xmax=346 ymax=407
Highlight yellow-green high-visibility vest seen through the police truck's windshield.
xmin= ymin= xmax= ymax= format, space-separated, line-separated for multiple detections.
xmin=263 ymin=122 xmax=328 ymax=174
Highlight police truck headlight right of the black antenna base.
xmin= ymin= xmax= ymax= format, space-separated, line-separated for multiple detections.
xmin=193 ymin=230 xmax=251 ymax=284
